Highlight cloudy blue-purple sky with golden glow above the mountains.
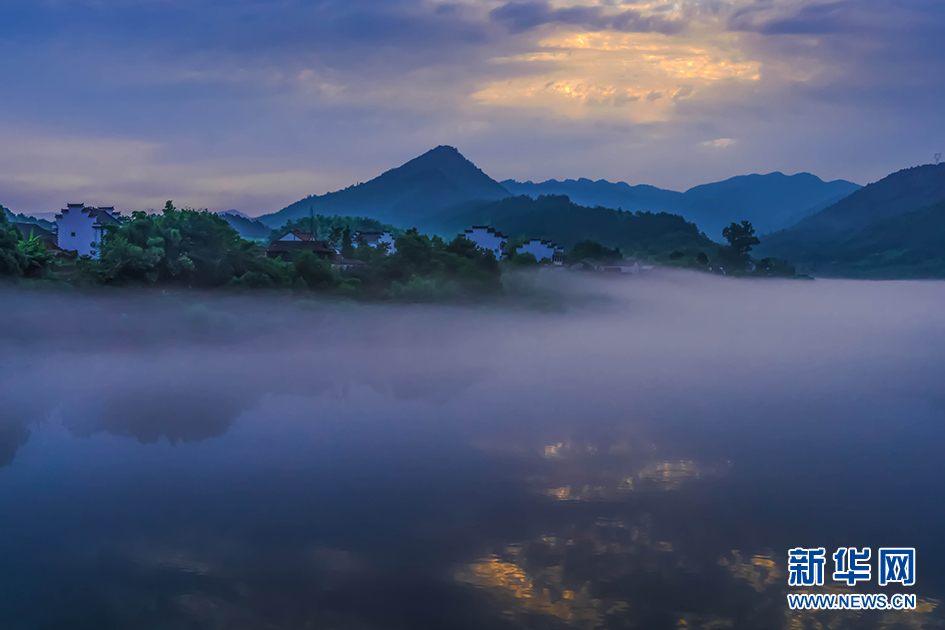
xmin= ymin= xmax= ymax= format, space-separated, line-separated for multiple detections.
xmin=0 ymin=0 xmax=945 ymax=215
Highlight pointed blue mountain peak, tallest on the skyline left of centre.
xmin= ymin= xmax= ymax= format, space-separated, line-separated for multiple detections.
xmin=259 ymin=146 xmax=509 ymax=228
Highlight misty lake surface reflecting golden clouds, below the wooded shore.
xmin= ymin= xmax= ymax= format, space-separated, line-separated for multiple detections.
xmin=0 ymin=271 xmax=945 ymax=629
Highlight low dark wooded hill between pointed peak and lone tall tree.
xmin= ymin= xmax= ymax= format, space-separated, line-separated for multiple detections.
xmin=444 ymin=195 xmax=716 ymax=256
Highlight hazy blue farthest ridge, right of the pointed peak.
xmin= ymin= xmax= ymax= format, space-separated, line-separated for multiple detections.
xmin=502 ymin=173 xmax=859 ymax=240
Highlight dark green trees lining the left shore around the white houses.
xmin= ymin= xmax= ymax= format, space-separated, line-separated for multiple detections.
xmin=0 ymin=202 xmax=502 ymax=300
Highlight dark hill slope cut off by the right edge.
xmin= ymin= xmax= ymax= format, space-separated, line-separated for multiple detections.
xmin=757 ymin=164 xmax=945 ymax=277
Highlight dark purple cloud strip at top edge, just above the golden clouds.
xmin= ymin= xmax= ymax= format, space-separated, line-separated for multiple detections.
xmin=489 ymin=2 xmax=686 ymax=35
